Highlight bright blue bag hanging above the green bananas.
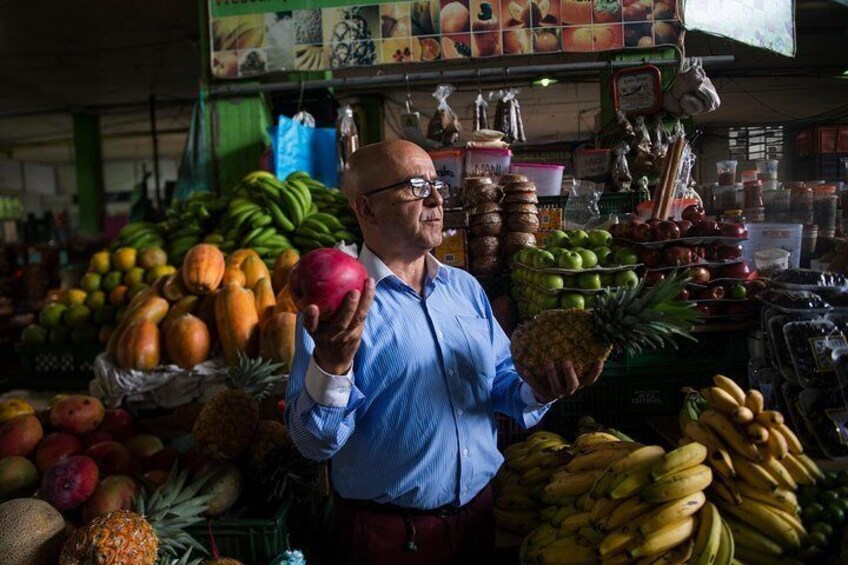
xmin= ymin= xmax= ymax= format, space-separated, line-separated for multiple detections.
xmin=271 ymin=116 xmax=338 ymax=186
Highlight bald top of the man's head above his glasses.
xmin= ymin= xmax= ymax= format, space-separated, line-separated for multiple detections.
xmin=342 ymin=140 xmax=436 ymax=200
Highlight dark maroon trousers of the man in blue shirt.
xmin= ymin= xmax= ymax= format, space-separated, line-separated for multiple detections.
xmin=335 ymin=485 xmax=495 ymax=565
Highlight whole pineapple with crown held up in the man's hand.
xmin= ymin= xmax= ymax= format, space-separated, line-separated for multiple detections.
xmin=511 ymin=272 xmax=698 ymax=392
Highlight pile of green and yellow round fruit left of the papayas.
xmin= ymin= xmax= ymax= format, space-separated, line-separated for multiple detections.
xmin=21 ymin=247 xmax=177 ymax=345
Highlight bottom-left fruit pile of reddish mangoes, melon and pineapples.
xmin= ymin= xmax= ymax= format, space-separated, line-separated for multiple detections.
xmin=0 ymin=390 xmax=301 ymax=565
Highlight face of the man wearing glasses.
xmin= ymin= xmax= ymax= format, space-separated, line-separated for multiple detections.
xmin=363 ymin=151 xmax=444 ymax=255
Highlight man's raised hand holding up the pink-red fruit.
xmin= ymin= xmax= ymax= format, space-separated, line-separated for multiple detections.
xmin=303 ymin=278 xmax=374 ymax=375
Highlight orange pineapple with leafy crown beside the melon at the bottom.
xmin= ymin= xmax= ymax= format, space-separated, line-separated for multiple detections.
xmin=59 ymin=466 xmax=211 ymax=565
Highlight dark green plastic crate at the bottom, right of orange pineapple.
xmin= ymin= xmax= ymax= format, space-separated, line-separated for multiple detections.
xmin=186 ymin=502 xmax=291 ymax=563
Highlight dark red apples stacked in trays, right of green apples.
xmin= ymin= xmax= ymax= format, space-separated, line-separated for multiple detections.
xmin=610 ymin=205 xmax=762 ymax=321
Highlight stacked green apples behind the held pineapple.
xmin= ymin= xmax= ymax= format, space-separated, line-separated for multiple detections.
xmin=512 ymin=230 xmax=639 ymax=318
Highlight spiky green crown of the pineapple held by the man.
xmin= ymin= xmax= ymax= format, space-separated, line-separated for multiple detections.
xmin=592 ymin=271 xmax=701 ymax=355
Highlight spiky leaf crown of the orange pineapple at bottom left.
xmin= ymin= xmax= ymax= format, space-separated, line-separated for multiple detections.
xmin=133 ymin=464 xmax=214 ymax=565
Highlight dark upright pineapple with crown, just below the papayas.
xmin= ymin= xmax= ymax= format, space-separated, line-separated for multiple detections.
xmin=192 ymin=353 xmax=282 ymax=459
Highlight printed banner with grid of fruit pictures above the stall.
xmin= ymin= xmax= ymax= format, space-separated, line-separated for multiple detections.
xmin=209 ymin=0 xmax=681 ymax=79
